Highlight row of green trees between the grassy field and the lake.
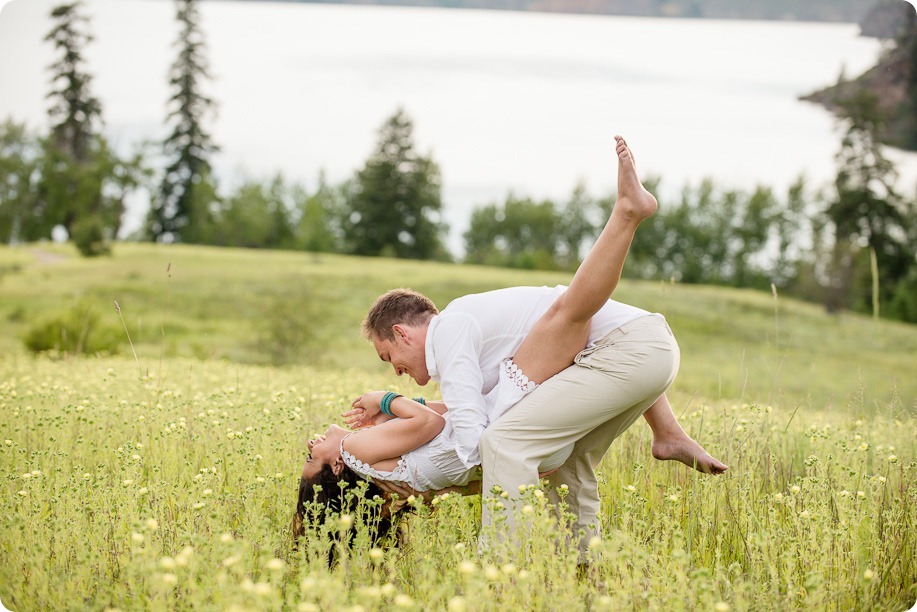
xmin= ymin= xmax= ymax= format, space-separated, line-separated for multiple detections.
xmin=0 ymin=0 xmax=917 ymax=322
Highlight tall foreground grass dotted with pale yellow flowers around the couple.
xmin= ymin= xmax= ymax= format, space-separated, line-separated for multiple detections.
xmin=0 ymin=358 xmax=917 ymax=610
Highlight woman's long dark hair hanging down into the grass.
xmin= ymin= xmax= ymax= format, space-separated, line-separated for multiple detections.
xmin=291 ymin=464 xmax=392 ymax=565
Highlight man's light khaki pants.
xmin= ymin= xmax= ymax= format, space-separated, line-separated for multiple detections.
xmin=480 ymin=315 xmax=679 ymax=552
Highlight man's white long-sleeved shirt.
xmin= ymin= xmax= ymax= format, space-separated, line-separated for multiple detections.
xmin=425 ymin=285 xmax=649 ymax=467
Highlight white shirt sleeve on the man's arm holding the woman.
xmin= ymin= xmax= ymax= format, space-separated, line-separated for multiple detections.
xmin=433 ymin=313 xmax=487 ymax=468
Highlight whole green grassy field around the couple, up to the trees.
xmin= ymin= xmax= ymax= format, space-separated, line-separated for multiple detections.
xmin=0 ymin=244 xmax=917 ymax=610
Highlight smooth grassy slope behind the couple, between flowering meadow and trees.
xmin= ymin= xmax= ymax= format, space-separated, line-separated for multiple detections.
xmin=0 ymin=243 xmax=917 ymax=411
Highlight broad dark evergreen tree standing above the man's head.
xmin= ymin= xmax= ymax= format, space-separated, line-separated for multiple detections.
xmin=343 ymin=109 xmax=447 ymax=259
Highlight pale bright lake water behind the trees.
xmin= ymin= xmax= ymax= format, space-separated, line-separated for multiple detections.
xmin=0 ymin=0 xmax=917 ymax=252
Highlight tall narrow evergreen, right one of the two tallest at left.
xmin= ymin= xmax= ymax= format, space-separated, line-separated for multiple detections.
xmin=147 ymin=0 xmax=217 ymax=242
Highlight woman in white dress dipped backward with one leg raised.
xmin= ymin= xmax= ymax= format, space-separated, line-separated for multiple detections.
xmin=297 ymin=136 xmax=725 ymax=532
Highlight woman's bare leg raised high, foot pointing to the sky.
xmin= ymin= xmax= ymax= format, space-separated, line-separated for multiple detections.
xmin=513 ymin=136 xmax=657 ymax=383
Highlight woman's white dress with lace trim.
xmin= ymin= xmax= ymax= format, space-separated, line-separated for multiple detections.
xmin=341 ymin=359 xmax=573 ymax=491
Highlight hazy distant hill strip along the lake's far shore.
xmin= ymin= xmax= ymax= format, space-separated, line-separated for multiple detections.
xmin=280 ymin=0 xmax=873 ymax=23
